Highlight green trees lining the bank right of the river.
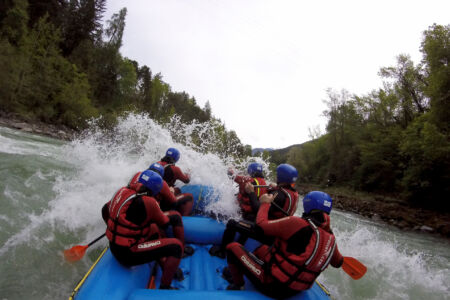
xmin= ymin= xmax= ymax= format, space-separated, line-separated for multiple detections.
xmin=278 ymin=24 xmax=450 ymax=210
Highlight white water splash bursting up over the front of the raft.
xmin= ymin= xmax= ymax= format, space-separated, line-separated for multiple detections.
xmin=49 ymin=114 xmax=274 ymax=236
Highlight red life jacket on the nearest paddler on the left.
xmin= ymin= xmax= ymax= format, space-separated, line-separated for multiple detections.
xmin=106 ymin=187 xmax=151 ymax=248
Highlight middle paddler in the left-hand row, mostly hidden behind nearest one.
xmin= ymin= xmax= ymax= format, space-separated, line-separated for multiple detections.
xmin=128 ymin=163 xmax=194 ymax=216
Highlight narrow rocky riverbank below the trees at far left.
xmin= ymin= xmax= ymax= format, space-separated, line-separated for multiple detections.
xmin=0 ymin=111 xmax=77 ymax=141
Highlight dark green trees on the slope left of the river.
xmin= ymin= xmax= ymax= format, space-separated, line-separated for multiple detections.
xmin=0 ymin=0 xmax=248 ymax=157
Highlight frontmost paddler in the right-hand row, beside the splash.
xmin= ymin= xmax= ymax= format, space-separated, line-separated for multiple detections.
xmin=229 ymin=162 xmax=267 ymax=221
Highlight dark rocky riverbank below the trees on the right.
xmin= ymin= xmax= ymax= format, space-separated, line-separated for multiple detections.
xmin=298 ymin=185 xmax=450 ymax=238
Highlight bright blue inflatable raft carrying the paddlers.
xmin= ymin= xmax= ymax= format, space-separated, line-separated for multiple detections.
xmin=69 ymin=185 xmax=330 ymax=300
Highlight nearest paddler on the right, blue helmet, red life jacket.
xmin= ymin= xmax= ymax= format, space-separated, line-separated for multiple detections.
xmin=227 ymin=191 xmax=344 ymax=298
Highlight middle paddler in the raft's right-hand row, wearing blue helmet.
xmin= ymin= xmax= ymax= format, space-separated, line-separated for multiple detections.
xmin=209 ymin=164 xmax=298 ymax=258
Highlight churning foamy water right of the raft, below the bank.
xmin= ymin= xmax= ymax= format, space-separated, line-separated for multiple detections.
xmin=321 ymin=211 xmax=450 ymax=299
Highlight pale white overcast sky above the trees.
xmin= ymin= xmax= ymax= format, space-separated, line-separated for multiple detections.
xmin=105 ymin=0 xmax=450 ymax=148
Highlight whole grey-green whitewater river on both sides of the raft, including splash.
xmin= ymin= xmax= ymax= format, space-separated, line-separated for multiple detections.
xmin=0 ymin=116 xmax=450 ymax=300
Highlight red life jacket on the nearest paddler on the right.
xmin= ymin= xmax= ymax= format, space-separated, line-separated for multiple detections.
xmin=269 ymin=219 xmax=336 ymax=291
